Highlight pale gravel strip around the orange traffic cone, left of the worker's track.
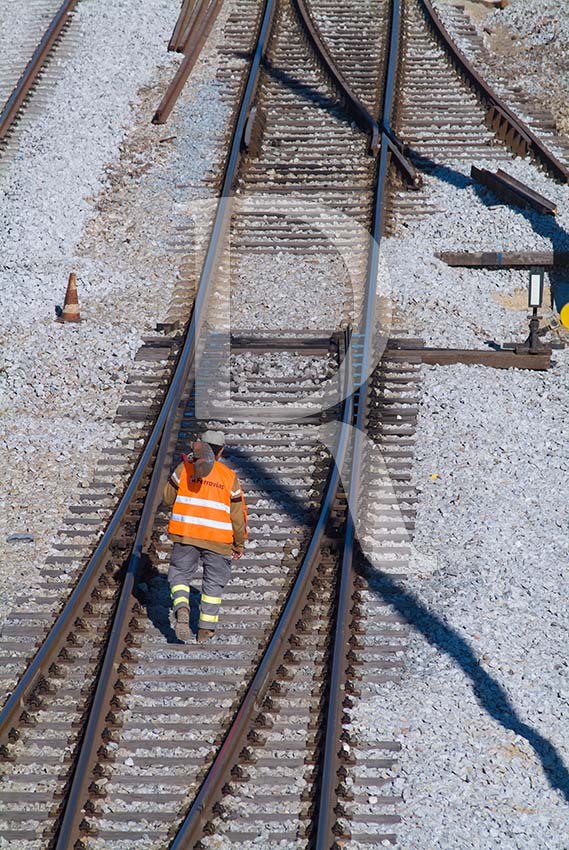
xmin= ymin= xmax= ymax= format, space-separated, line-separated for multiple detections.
xmin=0 ymin=0 xmax=234 ymax=619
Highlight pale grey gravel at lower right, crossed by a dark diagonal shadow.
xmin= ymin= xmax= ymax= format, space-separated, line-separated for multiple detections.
xmin=356 ymin=360 xmax=569 ymax=850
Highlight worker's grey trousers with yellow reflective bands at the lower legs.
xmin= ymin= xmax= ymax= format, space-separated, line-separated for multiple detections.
xmin=168 ymin=543 xmax=231 ymax=629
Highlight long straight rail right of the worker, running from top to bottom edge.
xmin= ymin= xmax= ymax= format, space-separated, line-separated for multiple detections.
xmin=313 ymin=0 xmax=401 ymax=850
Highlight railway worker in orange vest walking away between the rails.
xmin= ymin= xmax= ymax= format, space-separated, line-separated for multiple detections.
xmin=164 ymin=431 xmax=247 ymax=643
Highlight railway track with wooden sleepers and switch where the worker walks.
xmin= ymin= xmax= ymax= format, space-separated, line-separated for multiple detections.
xmin=0 ymin=0 xmax=568 ymax=850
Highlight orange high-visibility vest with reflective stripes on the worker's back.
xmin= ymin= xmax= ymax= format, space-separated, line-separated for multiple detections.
xmin=168 ymin=461 xmax=240 ymax=543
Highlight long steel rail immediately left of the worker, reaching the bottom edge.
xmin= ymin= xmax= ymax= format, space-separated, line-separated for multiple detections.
xmin=55 ymin=0 xmax=276 ymax=850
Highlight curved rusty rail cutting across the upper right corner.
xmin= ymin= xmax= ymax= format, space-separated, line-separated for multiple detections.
xmin=419 ymin=0 xmax=569 ymax=183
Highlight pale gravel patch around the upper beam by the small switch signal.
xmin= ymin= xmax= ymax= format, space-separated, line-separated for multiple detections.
xmin=382 ymin=151 xmax=569 ymax=347
